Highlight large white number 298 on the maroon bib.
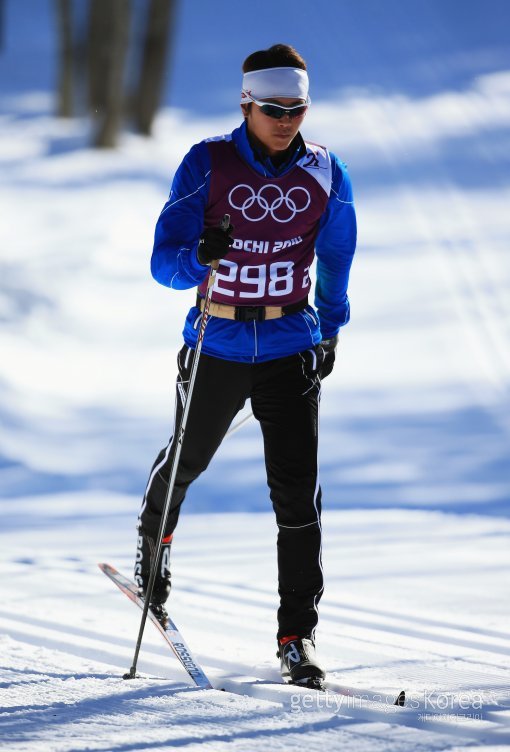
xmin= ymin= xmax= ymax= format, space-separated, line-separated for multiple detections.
xmin=214 ymin=259 xmax=294 ymax=298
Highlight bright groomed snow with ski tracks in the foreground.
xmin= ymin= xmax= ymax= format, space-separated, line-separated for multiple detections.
xmin=0 ymin=494 xmax=510 ymax=752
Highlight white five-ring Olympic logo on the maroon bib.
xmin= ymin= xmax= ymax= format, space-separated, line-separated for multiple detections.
xmin=228 ymin=183 xmax=312 ymax=222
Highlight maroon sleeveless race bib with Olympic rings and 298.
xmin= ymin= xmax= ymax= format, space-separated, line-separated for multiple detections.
xmin=199 ymin=136 xmax=331 ymax=306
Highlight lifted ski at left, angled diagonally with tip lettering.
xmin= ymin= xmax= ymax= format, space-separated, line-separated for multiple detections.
xmin=98 ymin=563 xmax=213 ymax=689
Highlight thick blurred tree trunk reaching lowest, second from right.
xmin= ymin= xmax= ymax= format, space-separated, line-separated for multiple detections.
xmin=88 ymin=0 xmax=130 ymax=148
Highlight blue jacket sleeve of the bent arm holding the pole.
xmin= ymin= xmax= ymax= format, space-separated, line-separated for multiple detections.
xmin=151 ymin=142 xmax=211 ymax=290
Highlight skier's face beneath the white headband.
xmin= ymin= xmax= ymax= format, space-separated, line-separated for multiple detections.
xmin=246 ymin=97 xmax=306 ymax=157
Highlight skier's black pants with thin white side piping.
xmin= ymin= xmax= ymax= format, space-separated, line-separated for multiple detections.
xmin=140 ymin=345 xmax=323 ymax=637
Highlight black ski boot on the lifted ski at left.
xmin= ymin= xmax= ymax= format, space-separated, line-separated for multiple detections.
xmin=135 ymin=528 xmax=172 ymax=627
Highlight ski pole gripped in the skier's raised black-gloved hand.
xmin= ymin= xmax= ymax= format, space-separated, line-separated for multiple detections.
xmin=123 ymin=214 xmax=230 ymax=679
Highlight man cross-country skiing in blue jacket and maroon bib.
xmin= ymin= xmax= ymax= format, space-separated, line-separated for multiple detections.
xmin=135 ymin=44 xmax=356 ymax=684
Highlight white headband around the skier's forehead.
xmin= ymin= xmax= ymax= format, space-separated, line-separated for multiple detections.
xmin=241 ymin=68 xmax=308 ymax=104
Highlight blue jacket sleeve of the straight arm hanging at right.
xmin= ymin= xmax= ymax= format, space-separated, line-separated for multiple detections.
xmin=315 ymin=154 xmax=356 ymax=339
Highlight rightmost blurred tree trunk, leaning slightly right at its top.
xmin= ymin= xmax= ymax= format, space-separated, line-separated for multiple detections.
xmin=133 ymin=0 xmax=177 ymax=136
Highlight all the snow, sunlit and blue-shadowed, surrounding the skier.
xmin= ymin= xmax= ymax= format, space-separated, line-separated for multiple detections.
xmin=0 ymin=0 xmax=510 ymax=752
